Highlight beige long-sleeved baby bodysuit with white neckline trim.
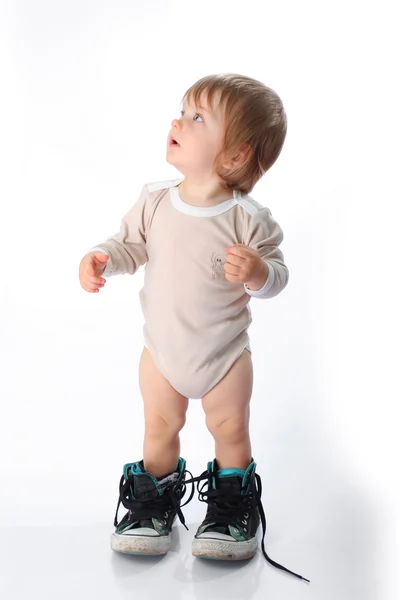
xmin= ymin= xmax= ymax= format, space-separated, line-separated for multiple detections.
xmin=90 ymin=179 xmax=289 ymax=399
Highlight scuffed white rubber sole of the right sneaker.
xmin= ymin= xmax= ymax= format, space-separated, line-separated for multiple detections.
xmin=192 ymin=534 xmax=258 ymax=560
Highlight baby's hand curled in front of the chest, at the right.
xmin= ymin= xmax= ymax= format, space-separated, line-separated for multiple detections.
xmin=224 ymin=244 xmax=268 ymax=290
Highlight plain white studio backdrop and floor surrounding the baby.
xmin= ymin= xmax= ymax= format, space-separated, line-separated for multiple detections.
xmin=0 ymin=0 xmax=400 ymax=600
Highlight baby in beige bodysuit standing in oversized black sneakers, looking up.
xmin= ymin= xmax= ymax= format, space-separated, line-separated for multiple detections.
xmin=79 ymin=74 xmax=309 ymax=581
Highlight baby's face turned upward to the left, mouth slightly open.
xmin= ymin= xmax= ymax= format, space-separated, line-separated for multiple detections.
xmin=167 ymin=95 xmax=224 ymax=180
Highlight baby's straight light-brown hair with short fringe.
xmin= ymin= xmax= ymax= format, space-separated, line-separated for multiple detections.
xmin=183 ymin=73 xmax=287 ymax=193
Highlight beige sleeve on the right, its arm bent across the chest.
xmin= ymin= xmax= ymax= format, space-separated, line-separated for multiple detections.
xmin=244 ymin=207 xmax=289 ymax=298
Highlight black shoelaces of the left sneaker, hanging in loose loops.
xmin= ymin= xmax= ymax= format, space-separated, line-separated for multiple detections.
xmin=114 ymin=470 xmax=195 ymax=531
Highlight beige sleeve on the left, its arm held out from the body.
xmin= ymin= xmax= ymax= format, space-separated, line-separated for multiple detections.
xmin=89 ymin=186 xmax=149 ymax=277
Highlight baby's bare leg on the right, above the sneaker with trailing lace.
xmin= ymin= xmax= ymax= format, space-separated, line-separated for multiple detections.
xmin=202 ymin=350 xmax=253 ymax=469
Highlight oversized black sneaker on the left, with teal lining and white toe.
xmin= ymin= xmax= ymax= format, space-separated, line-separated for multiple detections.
xmin=111 ymin=458 xmax=194 ymax=555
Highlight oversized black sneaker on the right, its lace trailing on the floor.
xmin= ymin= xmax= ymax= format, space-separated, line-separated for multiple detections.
xmin=185 ymin=459 xmax=310 ymax=583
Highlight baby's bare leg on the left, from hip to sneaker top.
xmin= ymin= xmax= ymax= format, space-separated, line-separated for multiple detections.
xmin=139 ymin=348 xmax=189 ymax=477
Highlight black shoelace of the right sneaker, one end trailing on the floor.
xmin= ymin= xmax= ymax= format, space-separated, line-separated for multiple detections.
xmin=185 ymin=471 xmax=310 ymax=583
